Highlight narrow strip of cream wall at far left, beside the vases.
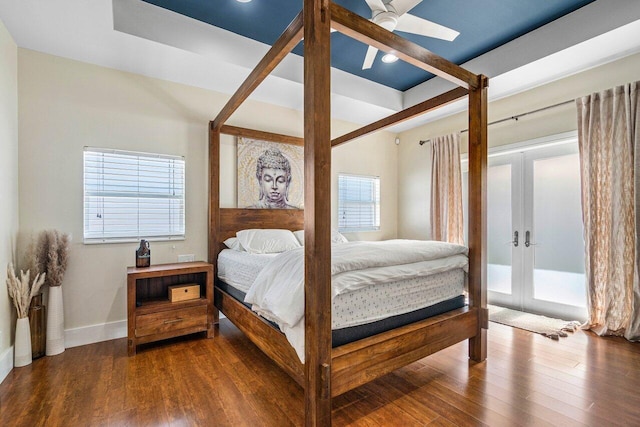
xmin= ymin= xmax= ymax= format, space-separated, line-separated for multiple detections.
xmin=0 ymin=21 xmax=18 ymax=382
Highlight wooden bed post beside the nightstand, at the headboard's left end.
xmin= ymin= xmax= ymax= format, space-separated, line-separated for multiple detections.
xmin=209 ymin=125 xmax=220 ymax=324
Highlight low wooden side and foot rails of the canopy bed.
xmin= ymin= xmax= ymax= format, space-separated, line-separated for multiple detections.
xmin=215 ymin=288 xmax=478 ymax=397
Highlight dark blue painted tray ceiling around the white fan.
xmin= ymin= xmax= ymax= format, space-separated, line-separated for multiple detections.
xmin=144 ymin=0 xmax=594 ymax=91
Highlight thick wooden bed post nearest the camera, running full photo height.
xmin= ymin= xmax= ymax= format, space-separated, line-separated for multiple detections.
xmin=303 ymin=0 xmax=331 ymax=426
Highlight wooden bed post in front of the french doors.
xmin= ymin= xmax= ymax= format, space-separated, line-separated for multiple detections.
xmin=468 ymin=75 xmax=489 ymax=362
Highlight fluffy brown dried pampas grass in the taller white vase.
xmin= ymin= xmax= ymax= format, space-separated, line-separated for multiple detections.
xmin=28 ymin=230 xmax=70 ymax=286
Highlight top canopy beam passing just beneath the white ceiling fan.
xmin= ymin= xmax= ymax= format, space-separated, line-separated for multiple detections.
xmin=331 ymin=3 xmax=479 ymax=89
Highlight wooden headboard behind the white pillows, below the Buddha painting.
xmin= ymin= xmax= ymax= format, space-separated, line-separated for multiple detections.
xmin=217 ymin=208 xmax=304 ymax=252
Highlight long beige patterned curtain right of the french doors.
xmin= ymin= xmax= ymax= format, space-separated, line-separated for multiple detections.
xmin=576 ymin=82 xmax=640 ymax=339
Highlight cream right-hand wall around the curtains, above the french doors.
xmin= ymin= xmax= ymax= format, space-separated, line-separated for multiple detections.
xmin=398 ymin=54 xmax=640 ymax=239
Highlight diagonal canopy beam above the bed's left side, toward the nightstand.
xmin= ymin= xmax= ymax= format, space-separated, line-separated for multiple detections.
xmin=213 ymin=12 xmax=303 ymax=130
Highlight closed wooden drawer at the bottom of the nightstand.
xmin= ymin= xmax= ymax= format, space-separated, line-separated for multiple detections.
xmin=136 ymin=305 xmax=207 ymax=337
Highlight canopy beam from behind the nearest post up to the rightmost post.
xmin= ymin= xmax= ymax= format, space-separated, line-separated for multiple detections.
xmin=331 ymin=87 xmax=469 ymax=147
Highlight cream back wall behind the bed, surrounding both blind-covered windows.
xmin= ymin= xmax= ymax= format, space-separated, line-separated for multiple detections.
xmin=18 ymin=49 xmax=397 ymax=345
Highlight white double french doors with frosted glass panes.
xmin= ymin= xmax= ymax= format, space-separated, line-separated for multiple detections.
xmin=464 ymin=138 xmax=586 ymax=320
